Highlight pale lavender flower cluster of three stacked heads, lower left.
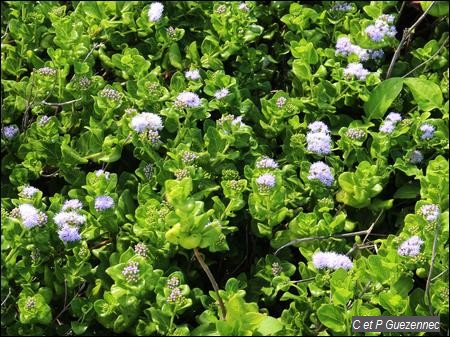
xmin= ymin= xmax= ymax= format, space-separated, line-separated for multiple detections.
xmin=53 ymin=199 xmax=86 ymax=242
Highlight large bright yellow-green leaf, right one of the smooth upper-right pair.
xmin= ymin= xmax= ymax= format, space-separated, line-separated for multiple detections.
xmin=404 ymin=77 xmax=443 ymax=111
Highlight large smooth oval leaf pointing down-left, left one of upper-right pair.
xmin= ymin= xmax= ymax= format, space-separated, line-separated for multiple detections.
xmin=364 ymin=77 xmax=403 ymax=120
